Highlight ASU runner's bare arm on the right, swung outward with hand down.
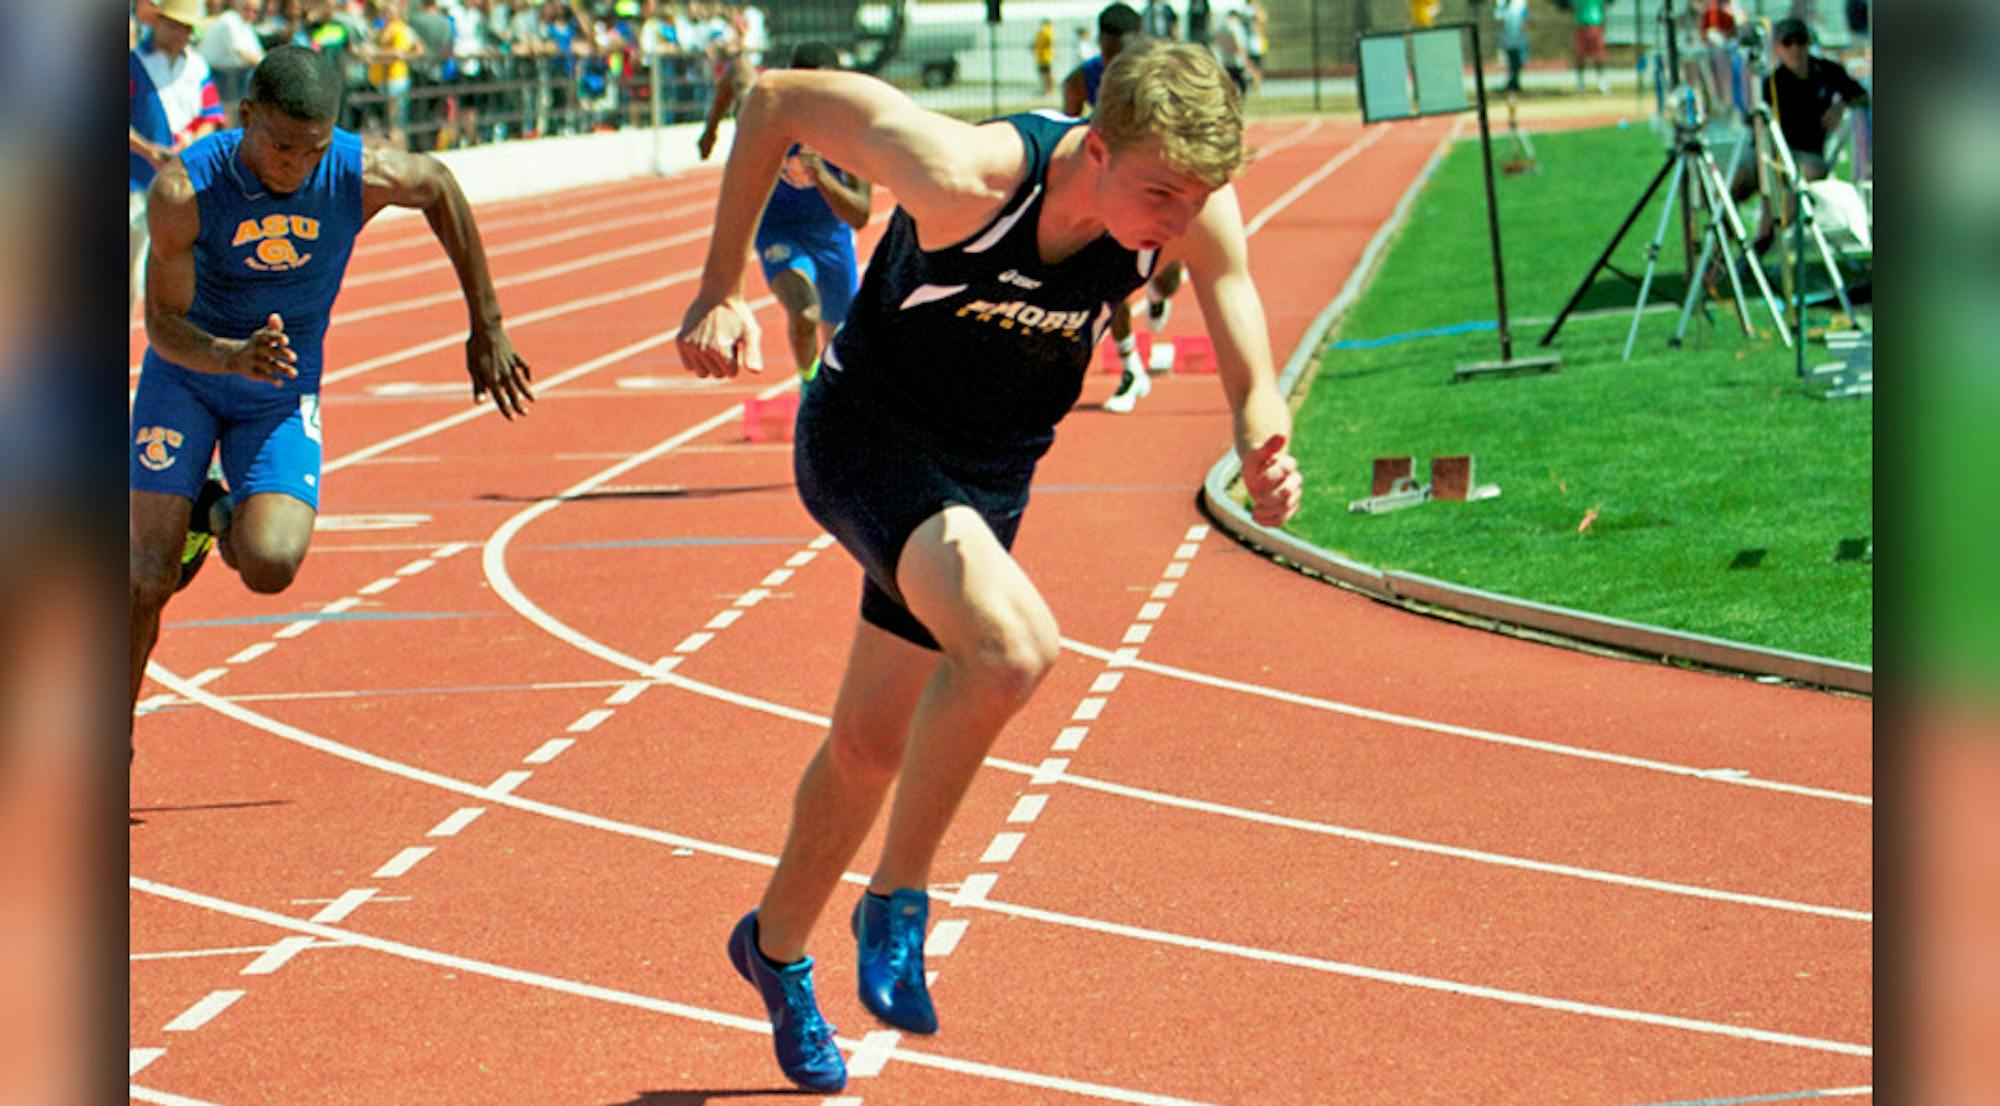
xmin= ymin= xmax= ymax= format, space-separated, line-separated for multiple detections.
xmin=362 ymin=142 xmax=534 ymax=418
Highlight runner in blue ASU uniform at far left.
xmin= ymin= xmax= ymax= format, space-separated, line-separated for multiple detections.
xmin=130 ymin=46 xmax=534 ymax=728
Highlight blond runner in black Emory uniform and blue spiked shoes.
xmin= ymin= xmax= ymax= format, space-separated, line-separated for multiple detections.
xmin=678 ymin=44 xmax=1300 ymax=1090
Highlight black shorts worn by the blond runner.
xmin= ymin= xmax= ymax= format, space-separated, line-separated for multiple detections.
xmin=792 ymin=370 xmax=1034 ymax=650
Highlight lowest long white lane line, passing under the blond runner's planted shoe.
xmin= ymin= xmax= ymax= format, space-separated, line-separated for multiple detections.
xmin=128 ymin=876 xmax=1210 ymax=1106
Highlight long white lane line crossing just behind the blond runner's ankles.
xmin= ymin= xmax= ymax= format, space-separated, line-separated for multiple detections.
xmin=145 ymin=666 xmax=1872 ymax=1056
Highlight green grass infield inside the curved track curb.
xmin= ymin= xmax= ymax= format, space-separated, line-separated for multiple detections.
xmin=1290 ymin=126 xmax=1874 ymax=664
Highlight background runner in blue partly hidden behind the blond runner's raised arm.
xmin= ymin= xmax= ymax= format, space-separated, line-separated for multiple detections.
xmin=696 ymin=42 xmax=874 ymax=380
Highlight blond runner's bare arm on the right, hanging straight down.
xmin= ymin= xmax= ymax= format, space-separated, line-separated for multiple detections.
xmin=1176 ymin=186 xmax=1300 ymax=526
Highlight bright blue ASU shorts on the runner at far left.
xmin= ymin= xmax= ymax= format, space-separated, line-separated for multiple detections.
xmin=130 ymin=356 xmax=322 ymax=510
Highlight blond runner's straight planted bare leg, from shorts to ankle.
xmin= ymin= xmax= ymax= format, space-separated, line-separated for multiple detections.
xmin=758 ymin=622 xmax=938 ymax=964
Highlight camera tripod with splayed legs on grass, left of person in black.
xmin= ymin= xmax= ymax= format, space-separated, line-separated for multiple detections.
xmin=1540 ymin=88 xmax=1792 ymax=360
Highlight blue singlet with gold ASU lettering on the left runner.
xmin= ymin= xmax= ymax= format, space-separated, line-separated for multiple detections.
xmin=144 ymin=128 xmax=362 ymax=394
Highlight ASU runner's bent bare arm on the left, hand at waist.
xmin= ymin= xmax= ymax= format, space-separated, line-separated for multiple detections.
xmin=146 ymin=158 xmax=298 ymax=384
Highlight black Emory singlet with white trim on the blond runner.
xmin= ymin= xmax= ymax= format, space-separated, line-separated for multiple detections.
xmin=814 ymin=112 xmax=1158 ymax=468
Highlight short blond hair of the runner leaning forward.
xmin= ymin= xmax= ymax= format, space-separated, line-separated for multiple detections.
xmin=1090 ymin=40 xmax=1244 ymax=188
